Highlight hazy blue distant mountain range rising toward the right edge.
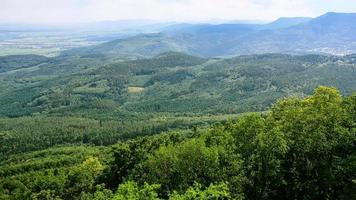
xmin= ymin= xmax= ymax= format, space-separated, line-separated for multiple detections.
xmin=64 ymin=13 xmax=356 ymax=57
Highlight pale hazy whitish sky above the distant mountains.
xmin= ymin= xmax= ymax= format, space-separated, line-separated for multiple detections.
xmin=0 ymin=0 xmax=356 ymax=24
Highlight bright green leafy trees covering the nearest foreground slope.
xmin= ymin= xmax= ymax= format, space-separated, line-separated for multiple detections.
xmin=0 ymin=86 xmax=356 ymax=200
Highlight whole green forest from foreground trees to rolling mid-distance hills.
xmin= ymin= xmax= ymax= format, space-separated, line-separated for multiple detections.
xmin=0 ymin=49 xmax=356 ymax=200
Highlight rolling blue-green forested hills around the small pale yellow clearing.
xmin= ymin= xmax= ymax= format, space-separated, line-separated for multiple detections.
xmin=0 ymin=52 xmax=356 ymax=117
